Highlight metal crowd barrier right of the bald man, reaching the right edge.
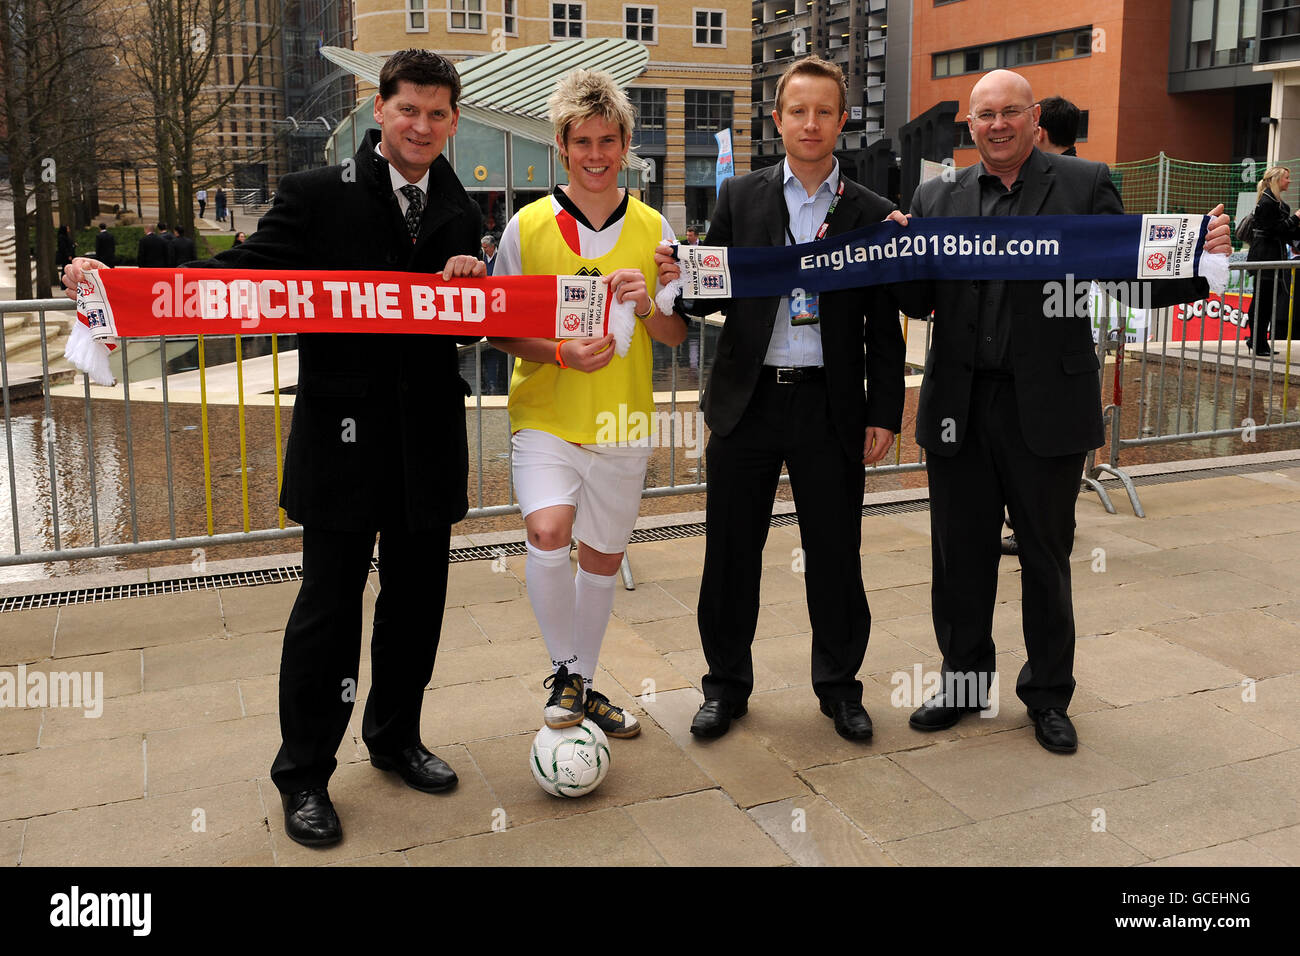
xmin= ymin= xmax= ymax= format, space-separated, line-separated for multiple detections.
xmin=1084 ymin=260 xmax=1300 ymax=518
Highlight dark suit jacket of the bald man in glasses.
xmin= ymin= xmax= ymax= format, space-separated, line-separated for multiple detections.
xmin=893 ymin=150 xmax=1209 ymax=457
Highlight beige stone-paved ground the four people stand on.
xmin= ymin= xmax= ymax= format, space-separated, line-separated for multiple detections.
xmin=0 ymin=463 xmax=1300 ymax=866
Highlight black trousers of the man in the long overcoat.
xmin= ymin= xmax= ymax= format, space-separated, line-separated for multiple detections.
xmin=270 ymin=525 xmax=451 ymax=793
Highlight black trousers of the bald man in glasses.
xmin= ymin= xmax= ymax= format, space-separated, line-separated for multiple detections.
xmin=926 ymin=376 xmax=1084 ymax=709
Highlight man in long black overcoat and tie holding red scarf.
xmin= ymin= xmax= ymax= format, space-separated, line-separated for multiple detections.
xmin=65 ymin=49 xmax=484 ymax=845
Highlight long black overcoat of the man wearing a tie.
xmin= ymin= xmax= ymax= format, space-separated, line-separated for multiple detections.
xmin=189 ymin=130 xmax=482 ymax=531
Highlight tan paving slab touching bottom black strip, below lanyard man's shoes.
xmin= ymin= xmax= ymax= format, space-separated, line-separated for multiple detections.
xmin=624 ymin=790 xmax=790 ymax=866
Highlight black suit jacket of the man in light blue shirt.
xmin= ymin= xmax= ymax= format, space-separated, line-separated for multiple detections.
xmin=697 ymin=164 xmax=905 ymax=460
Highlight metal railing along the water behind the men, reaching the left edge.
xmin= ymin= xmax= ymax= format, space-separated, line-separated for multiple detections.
xmin=0 ymin=299 xmax=928 ymax=567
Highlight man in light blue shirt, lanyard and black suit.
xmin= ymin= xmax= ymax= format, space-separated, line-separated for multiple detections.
xmin=660 ymin=57 xmax=904 ymax=740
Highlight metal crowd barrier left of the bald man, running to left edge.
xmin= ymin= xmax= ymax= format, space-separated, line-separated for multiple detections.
xmin=0 ymin=299 xmax=930 ymax=567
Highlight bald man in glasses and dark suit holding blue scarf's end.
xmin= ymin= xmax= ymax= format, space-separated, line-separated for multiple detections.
xmin=894 ymin=70 xmax=1230 ymax=753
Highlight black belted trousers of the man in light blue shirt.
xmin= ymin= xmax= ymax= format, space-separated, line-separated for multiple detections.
xmin=698 ymin=380 xmax=871 ymax=704
